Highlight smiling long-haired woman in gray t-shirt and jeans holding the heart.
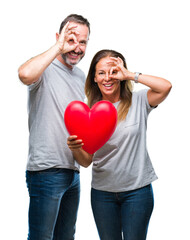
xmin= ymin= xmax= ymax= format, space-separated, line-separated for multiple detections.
xmin=68 ymin=50 xmax=171 ymax=240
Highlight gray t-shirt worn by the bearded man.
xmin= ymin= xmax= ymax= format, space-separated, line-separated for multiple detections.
xmin=27 ymin=59 xmax=85 ymax=171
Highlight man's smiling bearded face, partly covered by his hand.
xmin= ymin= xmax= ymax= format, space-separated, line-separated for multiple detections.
xmin=61 ymin=22 xmax=89 ymax=67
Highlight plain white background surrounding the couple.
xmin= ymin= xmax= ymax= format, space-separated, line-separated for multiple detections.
xmin=0 ymin=0 xmax=190 ymax=240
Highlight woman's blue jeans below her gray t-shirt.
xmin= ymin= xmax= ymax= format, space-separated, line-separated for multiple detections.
xmin=91 ymin=185 xmax=154 ymax=240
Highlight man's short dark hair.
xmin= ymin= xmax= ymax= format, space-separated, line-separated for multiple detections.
xmin=59 ymin=14 xmax=90 ymax=34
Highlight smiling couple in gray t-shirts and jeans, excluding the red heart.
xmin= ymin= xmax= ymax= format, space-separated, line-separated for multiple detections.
xmin=19 ymin=14 xmax=171 ymax=240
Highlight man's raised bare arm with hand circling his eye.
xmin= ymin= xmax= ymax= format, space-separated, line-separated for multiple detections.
xmin=18 ymin=22 xmax=78 ymax=85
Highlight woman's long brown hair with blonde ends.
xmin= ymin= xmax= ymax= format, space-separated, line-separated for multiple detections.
xmin=85 ymin=49 xmax=133 ymax=121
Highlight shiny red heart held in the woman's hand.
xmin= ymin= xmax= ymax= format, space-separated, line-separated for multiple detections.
xmin=64 ymin=101 xmax=117 ymax=154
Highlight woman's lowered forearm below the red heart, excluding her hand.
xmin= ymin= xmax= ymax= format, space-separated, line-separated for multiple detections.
xmin=72 ymin=148 xmax=93 ymax=167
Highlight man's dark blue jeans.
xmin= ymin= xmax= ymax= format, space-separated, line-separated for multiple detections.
xmin=26 ymin=168 xmax=80 ymax=240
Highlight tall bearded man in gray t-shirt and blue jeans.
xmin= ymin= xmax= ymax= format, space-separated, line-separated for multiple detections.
xmin=19 ymin=14 xmax=90 ymax=240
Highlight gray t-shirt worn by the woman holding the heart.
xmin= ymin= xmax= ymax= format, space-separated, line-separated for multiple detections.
xmin=92 ymin=89 xmax=157 ymax=192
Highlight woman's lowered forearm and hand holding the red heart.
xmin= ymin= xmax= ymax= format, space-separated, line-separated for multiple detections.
xmin=67 ymin=135 xmax=93 ymax=167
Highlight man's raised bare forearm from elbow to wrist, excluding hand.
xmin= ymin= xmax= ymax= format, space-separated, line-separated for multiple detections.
xmin=18 ymin=44 xmax=60 ymax=85
